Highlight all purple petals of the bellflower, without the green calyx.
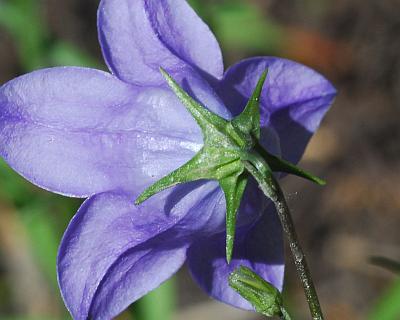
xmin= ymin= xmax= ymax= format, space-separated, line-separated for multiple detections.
xmin=0 ymin=0 xmax=336 ymax=319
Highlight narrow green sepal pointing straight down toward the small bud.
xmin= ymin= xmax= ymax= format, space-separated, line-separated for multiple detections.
xmin=219 ymin=172 xmax=248 ymax=264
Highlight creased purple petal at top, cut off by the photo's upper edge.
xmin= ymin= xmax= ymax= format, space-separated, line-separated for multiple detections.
xmin=98 ymin=0 xmax=223 ymax=85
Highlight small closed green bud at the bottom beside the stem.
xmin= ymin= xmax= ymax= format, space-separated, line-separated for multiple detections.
xmin=229 ymin=266 xmax=290 ymax=319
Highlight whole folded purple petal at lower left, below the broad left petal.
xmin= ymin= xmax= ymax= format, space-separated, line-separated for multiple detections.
xmin=58 ymin=181 xmax=275 ymax=319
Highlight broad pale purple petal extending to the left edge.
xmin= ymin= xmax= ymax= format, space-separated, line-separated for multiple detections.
xmin=0 ymin=68 xmax=208 ymax=197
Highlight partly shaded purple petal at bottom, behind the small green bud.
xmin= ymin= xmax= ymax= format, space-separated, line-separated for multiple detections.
xmin=188 ymin=211 xmax=284 ymax=310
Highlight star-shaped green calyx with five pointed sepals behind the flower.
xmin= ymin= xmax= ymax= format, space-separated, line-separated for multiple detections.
xmin=135 ymin=68 xmax=325 ymax=263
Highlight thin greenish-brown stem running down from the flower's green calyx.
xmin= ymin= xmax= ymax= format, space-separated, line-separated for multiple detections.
xmin=245 ymin=163 xmax=324 ymax=320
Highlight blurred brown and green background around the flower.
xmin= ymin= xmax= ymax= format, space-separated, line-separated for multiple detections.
xmin=0 ymin=0 xmax=400 ymax=320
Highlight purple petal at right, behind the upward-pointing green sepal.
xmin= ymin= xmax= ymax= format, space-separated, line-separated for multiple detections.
xmin=220 ymin=57 xmax=336 ymax=163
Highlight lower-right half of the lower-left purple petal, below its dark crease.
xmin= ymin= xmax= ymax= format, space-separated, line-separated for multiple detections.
xmin=90 ymin=236 xmax=186 ymax=320
